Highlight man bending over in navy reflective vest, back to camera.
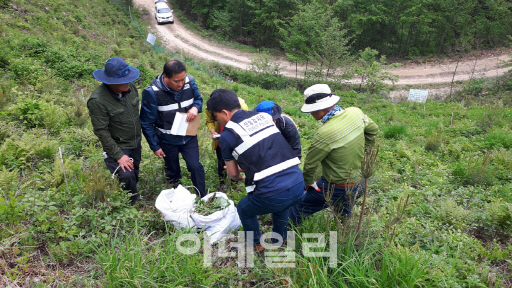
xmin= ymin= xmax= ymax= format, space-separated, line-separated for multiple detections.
xmin=207 ymin=89 xmax=305 ymax=252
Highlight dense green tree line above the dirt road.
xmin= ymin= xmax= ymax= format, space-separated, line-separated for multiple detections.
xmin=174 ymin=0 xmax=512 ymax=59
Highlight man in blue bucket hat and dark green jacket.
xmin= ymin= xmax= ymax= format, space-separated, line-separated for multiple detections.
xmin=87 ymin=58 xmax=141 ymax=205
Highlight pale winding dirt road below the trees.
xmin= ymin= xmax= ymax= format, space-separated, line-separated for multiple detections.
xmin=134 ymin=0 xmax=511 ymax=85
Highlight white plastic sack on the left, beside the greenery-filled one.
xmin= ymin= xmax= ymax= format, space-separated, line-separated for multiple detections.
xmin=155 ymin=185 xmax=196 ymax=230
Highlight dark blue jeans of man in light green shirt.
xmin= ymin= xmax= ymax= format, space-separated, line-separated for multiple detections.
xmin=290 ymin=176 xmax=362 ymax=225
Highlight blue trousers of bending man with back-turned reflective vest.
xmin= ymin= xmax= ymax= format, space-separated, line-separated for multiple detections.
xmin=236 ymin=181 xmax=306 ymax=244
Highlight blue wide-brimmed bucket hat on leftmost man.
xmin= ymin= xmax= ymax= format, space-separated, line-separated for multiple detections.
xmin=92 ymin=58 xmax=140 ymax=84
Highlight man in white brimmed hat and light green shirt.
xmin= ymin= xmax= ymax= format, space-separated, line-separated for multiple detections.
xmin=289 ymin=84 xmax=379 ymax=225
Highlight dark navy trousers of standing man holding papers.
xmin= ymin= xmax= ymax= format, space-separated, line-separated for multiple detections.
xmin=160 ymin=136 xmax=206 ymax=197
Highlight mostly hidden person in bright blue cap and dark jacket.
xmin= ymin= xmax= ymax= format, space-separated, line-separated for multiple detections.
xmin=253 ymin=100 xmax=302 ymax=159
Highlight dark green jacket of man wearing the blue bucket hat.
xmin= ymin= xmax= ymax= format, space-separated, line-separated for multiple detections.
xmin=87 ymin=83 xmax=141 ymax=160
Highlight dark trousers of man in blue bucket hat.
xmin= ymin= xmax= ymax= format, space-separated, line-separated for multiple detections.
xmin=104 ymin=144 xmax=142 ymax=205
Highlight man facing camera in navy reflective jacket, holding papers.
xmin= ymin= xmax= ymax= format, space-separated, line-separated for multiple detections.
xmin=140 ymin=60 xmax=206 ymax=197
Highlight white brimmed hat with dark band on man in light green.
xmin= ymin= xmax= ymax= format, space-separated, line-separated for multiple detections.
xmin=300 ymin=84 xmax=340 ymax=113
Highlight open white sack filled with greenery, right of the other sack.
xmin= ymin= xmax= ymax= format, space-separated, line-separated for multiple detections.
xmin=190 ymin=192 xmax=242 ymax=244
